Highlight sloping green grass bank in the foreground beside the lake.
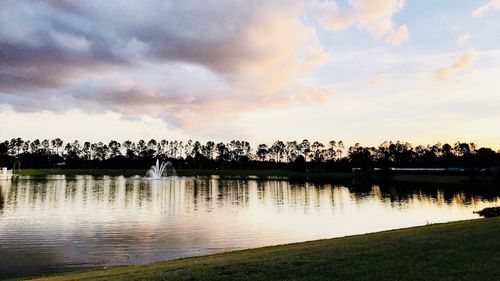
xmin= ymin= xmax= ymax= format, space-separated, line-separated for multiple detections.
xmin=21 ymin=218 xmax=500 ymax=281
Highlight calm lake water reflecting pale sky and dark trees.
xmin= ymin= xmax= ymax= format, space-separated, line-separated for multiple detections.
xmin=0 ymin=176 xmax=500 ymax=279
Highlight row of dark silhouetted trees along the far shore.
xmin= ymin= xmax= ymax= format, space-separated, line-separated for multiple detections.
xmin=0 ymin=138 xmax=500 ymax=171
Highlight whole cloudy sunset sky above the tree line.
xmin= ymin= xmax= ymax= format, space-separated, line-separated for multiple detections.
xmin=0 ymin=0 xmax=500 ymax=149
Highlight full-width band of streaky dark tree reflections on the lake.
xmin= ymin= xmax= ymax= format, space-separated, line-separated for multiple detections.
xmin=0 ymin=176 xmax=498 ymax=214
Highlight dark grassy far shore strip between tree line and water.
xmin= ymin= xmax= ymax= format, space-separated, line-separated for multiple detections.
xmin=12 ymin=169 xmax=499 ymax=186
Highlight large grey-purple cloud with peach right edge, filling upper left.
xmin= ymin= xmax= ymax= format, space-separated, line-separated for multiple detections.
xmin=0 ymin=0 xmax=333 ymax=130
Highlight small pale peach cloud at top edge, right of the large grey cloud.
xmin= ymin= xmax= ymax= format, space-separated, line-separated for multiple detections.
xmin=309 ymin=0 xmax=410 ymax=45
